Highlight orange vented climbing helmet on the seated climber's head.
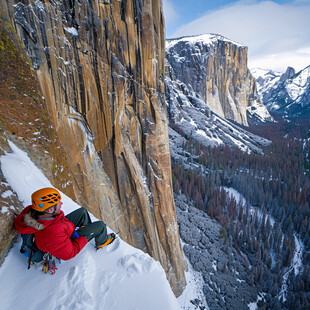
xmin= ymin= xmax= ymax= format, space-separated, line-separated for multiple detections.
xmin=31 ymin=187 xmax=61 ymax=212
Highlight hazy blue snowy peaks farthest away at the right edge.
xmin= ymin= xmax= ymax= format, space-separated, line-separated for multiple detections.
xmin=252 ymin=66 xmax=310 ymax=118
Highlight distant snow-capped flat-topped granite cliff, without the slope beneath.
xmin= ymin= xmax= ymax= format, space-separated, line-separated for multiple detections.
xmin=166 ymin=34 xmax=261 ymax=125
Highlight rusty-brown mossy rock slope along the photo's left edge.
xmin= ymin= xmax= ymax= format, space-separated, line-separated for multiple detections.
xmin=0 ymin=7 xmax=73 ymax=265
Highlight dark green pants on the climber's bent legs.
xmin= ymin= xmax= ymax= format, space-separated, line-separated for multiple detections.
xmin=66 ymin=208 xmax=108 ymax=243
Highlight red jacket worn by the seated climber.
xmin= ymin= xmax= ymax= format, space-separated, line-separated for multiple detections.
xmin=14 ymin=206 xmax=87 ymax=260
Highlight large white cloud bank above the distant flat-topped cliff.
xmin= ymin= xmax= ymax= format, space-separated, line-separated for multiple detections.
xmin=174 ymin=0 xmax=310 ymax=71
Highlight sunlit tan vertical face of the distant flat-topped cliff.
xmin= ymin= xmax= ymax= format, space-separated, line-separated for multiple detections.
xmin=204 ymin=41 xmax=254 ymax=125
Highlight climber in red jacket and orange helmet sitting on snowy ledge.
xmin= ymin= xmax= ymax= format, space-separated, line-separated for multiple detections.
xmin=14 ymin=188 xmax=116 ymax=260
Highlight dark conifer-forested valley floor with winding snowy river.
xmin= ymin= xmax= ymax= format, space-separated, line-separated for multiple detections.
xmin=172 ymin=119 xmax=310 ymax=309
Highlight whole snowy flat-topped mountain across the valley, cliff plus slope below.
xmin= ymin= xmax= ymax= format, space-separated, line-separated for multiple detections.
xmin=165 ymin=34 xmax=272 ymax=156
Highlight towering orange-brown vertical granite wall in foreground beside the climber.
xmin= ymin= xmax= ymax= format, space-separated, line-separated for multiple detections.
xmin=0 ymin=0 xmax=185 ymax=295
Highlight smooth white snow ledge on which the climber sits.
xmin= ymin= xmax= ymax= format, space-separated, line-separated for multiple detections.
xmin=0 ymin=142 xmax=180 ymax=310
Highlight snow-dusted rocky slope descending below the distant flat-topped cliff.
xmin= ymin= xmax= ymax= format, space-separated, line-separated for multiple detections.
xmin=165 ymin=78 xmax=270 ymax=158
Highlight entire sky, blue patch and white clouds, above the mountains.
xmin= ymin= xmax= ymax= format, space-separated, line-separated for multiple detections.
xmin=163 ymin=0 xmax=310 ymax=71
